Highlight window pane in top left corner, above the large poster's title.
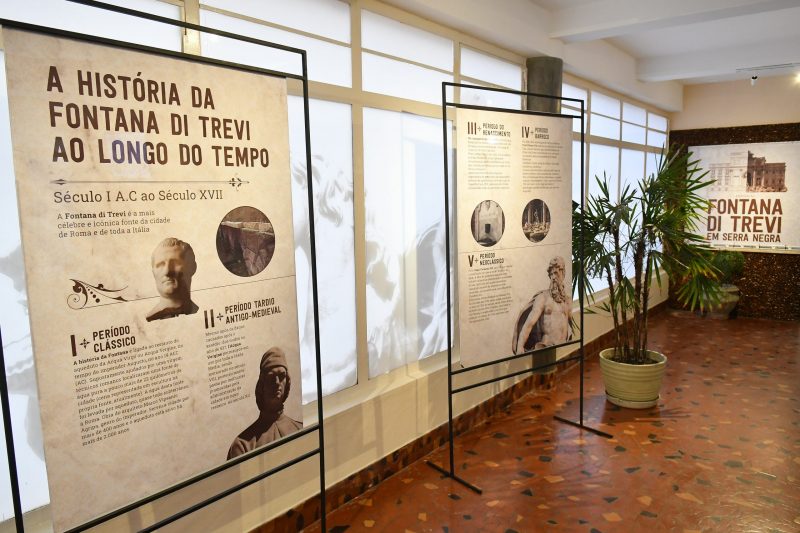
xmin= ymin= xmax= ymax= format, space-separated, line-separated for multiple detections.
xmin=0 ymin=0 xmax=183 ymax=49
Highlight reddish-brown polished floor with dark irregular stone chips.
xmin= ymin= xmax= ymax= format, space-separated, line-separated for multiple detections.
xmin=306 ymin=313 xmax=800 ymax=533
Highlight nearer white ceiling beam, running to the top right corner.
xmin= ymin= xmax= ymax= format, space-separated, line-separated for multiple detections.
xmin=549 ymin=0 xmax=797 ymax=43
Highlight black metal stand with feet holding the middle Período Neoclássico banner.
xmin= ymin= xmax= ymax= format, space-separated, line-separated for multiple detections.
xmin=426 ymin=82 xmax=613 ymax=494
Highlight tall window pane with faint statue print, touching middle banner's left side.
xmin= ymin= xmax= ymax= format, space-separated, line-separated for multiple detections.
xmin=364 ymin=109 xmax=452 ymax=377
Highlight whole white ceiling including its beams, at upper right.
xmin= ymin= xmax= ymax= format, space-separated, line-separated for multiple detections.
xmin=384 ymin=0 xmax=800 ymax=86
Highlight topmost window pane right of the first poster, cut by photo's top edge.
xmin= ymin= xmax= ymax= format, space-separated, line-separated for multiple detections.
xmin=202 ymin=0 xmax=350 ymax=42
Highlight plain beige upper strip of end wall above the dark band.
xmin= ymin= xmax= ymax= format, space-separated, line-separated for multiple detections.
xmin=671 ymin=76 xmax=800 ymax=130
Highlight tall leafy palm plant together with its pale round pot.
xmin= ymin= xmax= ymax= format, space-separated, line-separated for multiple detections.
xmin=572 ymin=149 xmax=720 ymax=408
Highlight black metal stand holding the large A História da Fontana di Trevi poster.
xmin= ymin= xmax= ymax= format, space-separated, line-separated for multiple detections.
xmin=0 ymin=0 xmax=326 ymax=533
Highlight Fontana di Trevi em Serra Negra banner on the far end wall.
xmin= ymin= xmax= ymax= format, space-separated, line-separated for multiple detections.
xmin=689 ymin=142 xmax=800 ymax=249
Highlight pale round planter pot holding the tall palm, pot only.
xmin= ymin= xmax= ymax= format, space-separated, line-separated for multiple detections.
xmin=600 ymin=348 xmax=667 ymax=409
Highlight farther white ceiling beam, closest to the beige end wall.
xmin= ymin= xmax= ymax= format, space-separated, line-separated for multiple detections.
xmin=636 ymin=37 xmax=800 ymax=82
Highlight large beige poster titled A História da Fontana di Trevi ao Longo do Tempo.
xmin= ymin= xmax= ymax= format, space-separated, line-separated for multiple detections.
xmin=3 ymin=29 xmax=302 ymax=530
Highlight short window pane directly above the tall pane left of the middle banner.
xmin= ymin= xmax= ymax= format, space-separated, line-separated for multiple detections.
xmin=361 ymin=52 xmax=453 ymax=105
